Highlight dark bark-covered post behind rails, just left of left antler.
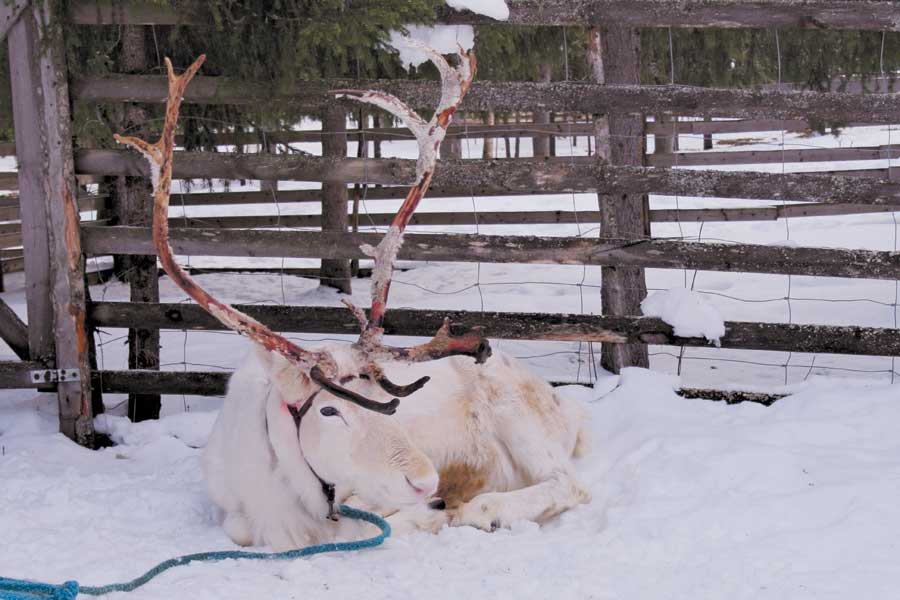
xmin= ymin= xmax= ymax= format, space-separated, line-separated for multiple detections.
xmin=113 ymin=25 xmax=162 ymax=422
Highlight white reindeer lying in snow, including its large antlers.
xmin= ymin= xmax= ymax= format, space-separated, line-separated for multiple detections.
xmin=116 ymin=47 xmax=588 ymax=550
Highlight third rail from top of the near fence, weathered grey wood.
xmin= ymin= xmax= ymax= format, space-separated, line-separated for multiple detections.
xmin=75 ymin=149 xmax=900 ymax=205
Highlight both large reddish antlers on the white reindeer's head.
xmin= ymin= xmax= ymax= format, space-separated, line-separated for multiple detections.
xmin=115 ymin=48 xmax=490 ymax=414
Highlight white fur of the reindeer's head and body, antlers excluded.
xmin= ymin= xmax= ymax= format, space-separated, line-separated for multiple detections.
xmin=204 ymin=346 xmax=589 ymax=550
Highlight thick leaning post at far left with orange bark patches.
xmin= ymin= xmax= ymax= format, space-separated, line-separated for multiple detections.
xmin=9 ymin=0 xmax=94 ymax=446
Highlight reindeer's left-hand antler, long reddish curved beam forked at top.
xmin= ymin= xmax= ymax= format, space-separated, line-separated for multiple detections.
xmin=115 ymin=55 xmax=336 ymax=380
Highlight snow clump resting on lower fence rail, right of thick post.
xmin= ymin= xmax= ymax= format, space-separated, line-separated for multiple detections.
xmin=641 ymin=288 xmax=725 ymax=346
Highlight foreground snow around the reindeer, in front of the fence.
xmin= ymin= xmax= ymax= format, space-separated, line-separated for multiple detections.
xmin=0 ymin=369 xmax=900 ymax=600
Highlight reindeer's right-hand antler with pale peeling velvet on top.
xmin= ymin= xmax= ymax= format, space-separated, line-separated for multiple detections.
xmin=335 ymin=38 xmax=491 ymax=396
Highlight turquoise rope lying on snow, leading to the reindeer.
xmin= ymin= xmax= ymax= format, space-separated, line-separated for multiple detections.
xmin=0 ymin=504 xmax=391 ymax=600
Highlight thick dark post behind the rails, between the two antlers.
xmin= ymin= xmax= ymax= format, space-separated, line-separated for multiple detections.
xmin=319 ymin=103 xmax=350 ymax=294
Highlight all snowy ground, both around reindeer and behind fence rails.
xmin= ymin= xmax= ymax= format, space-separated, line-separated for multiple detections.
xmin=0 ymin=120 xmax=900 ymax=600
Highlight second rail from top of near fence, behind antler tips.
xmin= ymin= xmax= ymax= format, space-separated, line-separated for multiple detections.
xmin=74 ymin=75 xmax=900 ymax=123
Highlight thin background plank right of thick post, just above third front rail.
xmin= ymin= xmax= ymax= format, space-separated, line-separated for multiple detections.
xmin=647 ymin=145 xmax=900 ymax=167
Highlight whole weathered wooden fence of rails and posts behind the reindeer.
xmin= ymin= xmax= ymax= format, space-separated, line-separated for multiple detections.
xmin=0 ymin=0 xmax=900 ymax=443
